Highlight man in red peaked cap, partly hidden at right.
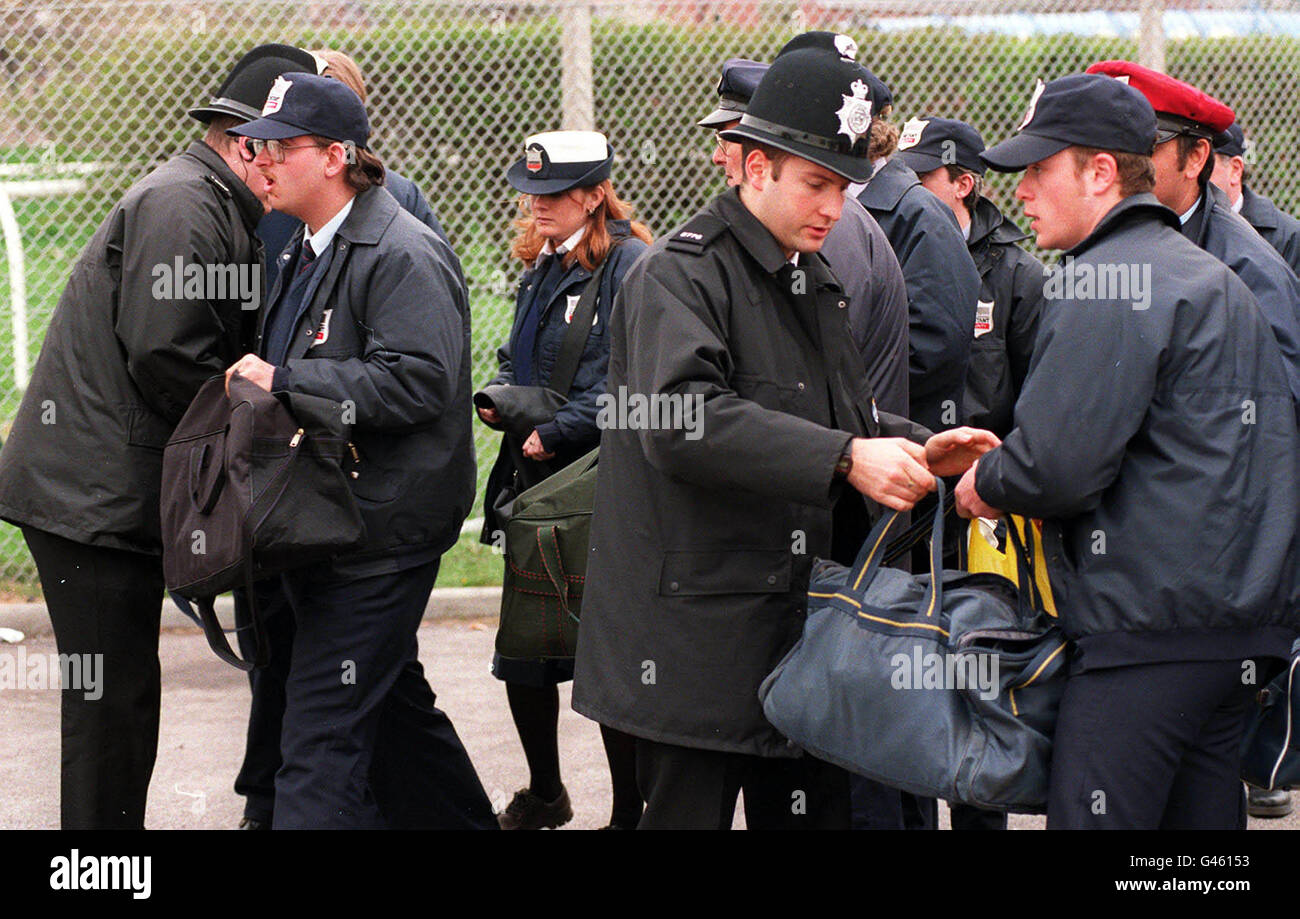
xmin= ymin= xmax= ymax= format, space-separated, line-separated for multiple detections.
xmin=1088 ymin=61 xmax=1300 ymax=411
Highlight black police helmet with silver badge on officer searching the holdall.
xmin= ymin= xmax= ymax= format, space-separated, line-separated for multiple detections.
xmin=722 ymin=48 xmax=871 ymax=182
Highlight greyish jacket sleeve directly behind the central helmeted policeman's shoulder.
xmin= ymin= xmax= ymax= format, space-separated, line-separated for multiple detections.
xmin=822 ymin=198 xmax=909 ymax=416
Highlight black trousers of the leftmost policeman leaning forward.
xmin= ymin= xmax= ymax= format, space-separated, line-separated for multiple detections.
xmin=22 ymin=526 xmax=163 ymax=829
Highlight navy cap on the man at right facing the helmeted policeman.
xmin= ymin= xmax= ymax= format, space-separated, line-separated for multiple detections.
xmin=980 ymin=73 xmax=1156 ymax=173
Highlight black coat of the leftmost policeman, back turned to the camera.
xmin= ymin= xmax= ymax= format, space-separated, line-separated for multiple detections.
xmin=0 ymin=142 xmax=263 ymax=555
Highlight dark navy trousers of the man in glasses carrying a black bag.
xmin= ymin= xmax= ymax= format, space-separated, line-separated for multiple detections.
xmin=273 ymin=562 xmax=497 ymax=829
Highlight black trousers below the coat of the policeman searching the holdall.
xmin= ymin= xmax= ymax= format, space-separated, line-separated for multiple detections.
xmin=637 ymin=737 xmax=849 ymax=829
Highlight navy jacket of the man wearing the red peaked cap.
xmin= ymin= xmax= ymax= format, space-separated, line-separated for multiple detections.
xmin=1183 ymin=183 xmax=1300 ymax=411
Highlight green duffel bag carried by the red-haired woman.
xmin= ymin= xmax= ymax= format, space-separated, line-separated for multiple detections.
xmin=497 ymin=448 xmax=601 ymax=660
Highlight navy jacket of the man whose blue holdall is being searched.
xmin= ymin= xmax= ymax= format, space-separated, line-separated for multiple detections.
xmin=975 ymin=194 xmax=1300 ymax=667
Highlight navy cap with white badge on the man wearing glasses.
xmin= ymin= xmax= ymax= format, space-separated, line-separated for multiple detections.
xmin=226 ymin=73 xmax=371 ymax=149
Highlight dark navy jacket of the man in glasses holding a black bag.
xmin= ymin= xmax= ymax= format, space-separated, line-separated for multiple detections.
xmin=259 ymin=187 xmax=476 ymax=576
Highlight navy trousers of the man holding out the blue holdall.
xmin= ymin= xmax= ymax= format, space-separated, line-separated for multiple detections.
xmin=1048 ymin=660 xmax=1255 ymax=829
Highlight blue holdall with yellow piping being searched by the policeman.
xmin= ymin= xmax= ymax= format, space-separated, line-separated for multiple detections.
xmin=758 ymin=480 xmax=1067 ymax=814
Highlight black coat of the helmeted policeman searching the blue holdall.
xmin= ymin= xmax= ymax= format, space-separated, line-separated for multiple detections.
xmin=573 ymin=188 xmax=928 ymax=757
